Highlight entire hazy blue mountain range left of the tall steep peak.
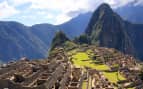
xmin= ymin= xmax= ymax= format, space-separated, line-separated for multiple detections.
xmin=0 ymin=13 xmax=91 ymax=62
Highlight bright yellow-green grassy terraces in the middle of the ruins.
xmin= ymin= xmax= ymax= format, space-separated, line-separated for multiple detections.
xmin=69 ymin=50 xmax=125 ymax=89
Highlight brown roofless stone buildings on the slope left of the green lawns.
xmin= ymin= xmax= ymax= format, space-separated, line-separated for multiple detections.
xmin=0 ymin=49 xmax=83 ymax=89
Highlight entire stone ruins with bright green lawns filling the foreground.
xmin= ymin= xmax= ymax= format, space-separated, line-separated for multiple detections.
xmin=0 ymin=46 xmax=143 ymax=89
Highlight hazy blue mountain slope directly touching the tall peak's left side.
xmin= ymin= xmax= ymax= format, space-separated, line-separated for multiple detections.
xmin=58 ymin=12 xmax=92 ymax=39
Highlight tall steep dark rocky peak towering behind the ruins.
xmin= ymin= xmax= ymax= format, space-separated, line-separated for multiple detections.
xmin=85 ymin=4 xmax=133 ymax=54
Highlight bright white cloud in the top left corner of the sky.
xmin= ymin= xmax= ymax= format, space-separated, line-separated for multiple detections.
xmin=0 ymin=1 xmax=19 ymax=19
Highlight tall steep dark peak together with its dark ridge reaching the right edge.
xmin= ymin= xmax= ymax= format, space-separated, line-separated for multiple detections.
xmin=85 ymin=4 xmax=143 ymax=58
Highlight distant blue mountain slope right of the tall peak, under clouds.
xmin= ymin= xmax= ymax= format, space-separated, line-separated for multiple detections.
xmin=115 ymin=3 xmax=143 ymax=24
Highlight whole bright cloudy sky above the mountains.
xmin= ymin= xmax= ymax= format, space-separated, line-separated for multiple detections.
xmin=0 ymin=0 xmax=143 ymax=26
